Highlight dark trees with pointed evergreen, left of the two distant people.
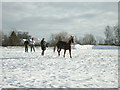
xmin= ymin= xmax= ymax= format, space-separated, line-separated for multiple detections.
xmin=2 ymin=30 xmax=31 ymax=46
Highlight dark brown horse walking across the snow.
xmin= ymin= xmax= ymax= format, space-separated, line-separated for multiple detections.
xmin=54 ymin=36 xmax=74 ymax=58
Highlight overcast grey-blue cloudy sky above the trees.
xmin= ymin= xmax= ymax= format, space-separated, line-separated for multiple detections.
xmin=2 ymin=2 xmax=118 ymax=39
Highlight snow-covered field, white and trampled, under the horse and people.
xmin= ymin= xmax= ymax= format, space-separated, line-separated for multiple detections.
xmin=0 ymin=46 xmax=118 ymax=88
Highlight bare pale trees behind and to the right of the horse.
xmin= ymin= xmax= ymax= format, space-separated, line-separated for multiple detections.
xmin=49 ymin=25 xmax=120 ymax=46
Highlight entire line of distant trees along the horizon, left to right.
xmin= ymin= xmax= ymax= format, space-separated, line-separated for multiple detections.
xmin=0 ymin=25 xmax=120 ymax=46
